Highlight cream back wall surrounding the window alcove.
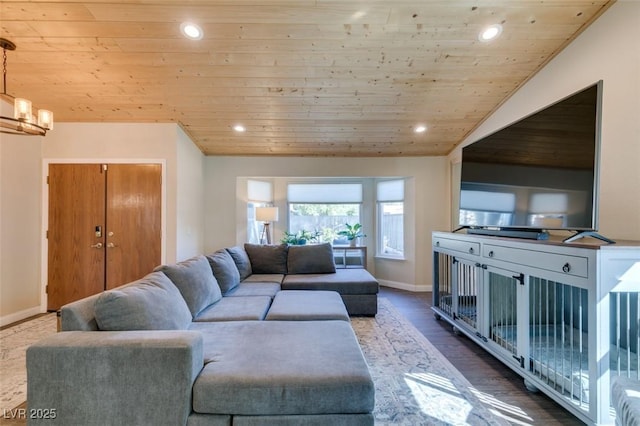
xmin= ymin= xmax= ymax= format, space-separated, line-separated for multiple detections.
xmin=205 ymin=157 xmax=449 ymax=290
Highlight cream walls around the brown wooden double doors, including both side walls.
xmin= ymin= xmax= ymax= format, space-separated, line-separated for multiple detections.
xmin=0 ymin=123 xmax=204 ymax=325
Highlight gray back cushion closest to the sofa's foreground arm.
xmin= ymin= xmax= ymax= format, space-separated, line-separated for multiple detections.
xmin=95 ymin=272 xmax=191 ymax=331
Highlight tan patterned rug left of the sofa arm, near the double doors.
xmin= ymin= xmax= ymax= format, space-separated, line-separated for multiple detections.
xmin=0 ymin=314 xmax=57 ymax=413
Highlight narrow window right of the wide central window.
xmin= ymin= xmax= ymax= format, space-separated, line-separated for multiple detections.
xmin=376 ymin=179 xmax=404 ymax=258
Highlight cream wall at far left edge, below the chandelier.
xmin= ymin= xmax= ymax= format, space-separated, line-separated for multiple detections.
xmin=0 ymin=131 xmax=43 ymax=326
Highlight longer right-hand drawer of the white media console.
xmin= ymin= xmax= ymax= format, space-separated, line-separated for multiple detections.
xmin=482 ymin=244 xmax=589 ymax=278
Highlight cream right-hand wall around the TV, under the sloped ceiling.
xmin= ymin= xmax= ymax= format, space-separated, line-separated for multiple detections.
xmin=450 ymin=1 xmax=640 ymax=240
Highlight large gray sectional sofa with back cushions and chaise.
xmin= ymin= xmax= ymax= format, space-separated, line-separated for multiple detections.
xmin=27 ymin=245 xmax=377 ymax=426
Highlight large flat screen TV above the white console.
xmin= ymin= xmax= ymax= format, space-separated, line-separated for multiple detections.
xmin=459 ymin=81 xmax=602 ymax=240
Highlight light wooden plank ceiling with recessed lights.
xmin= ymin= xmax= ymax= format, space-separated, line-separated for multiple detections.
xmin=0 ymin=0 xmax=612 ymax=157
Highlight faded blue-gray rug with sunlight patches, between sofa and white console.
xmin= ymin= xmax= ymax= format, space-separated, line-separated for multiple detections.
xmin=351 ymin=298 xmax=510 ymax=426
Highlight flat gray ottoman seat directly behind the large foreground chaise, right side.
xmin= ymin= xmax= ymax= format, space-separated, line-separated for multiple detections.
xmin=265 ymin=290 xmax=349 ymax=321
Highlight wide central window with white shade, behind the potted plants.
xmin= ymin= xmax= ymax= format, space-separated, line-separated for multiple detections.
xmin=287 ymin=183 xmax=362 ymax=244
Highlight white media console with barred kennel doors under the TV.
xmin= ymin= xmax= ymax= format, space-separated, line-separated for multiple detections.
xmin=432 ymin=232 xmax=640 ymax=425
